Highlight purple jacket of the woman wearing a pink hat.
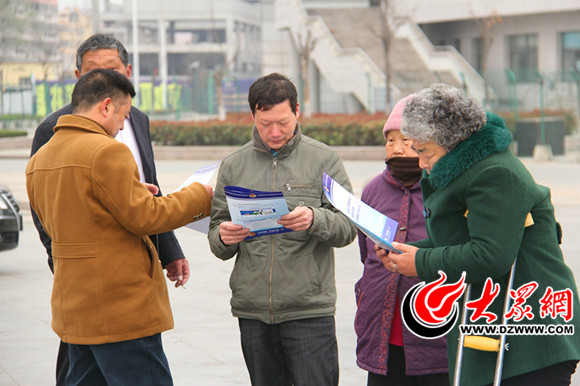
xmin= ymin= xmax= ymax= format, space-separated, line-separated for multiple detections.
xmin=355 ymin=167 xmax=448 ymax=375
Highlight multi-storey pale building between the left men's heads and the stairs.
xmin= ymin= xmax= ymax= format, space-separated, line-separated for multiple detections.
xmin=100 ymin=0 xmax=263 ymax=114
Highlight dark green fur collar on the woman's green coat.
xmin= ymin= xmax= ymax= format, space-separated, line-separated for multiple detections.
xmin=428 ymin=112 xmax=512 ymax=189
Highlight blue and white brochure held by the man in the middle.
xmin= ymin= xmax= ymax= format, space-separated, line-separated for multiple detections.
xmin=224 ymin=186 xmax=292 ymax=239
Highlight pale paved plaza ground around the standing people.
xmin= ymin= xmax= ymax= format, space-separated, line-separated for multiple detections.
xmin=0 ymin=153 xmax=580 ymax=386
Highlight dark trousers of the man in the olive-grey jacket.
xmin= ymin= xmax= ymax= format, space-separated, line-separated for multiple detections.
xmin=239 ymin=316 xmax=338 ymax=386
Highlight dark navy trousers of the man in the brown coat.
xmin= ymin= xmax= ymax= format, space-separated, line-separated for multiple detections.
xmin=66 ymin=334 xmax=173 ymax=386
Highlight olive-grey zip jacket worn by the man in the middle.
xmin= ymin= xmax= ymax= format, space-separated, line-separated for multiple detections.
xmin=208 ymin=126 xmax=356 ymax=323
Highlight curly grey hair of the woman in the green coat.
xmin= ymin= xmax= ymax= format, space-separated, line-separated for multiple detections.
xmin=401 ymin=83 xmax=487 ymax=152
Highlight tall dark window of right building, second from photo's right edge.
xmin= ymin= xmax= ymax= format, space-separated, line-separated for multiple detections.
xmin=508 ymin=34 xmax=538 ymax=82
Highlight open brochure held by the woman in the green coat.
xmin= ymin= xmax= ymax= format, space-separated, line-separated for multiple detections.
xmin=322 ymin=173 xmax=400 ymax=253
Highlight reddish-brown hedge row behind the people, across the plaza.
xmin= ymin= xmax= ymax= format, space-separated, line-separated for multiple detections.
xmin=151 ymin=111 xmax=576 ymax=146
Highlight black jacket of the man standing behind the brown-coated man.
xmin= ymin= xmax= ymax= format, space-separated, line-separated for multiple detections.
xmin=30 ymin=104 xmax=185 ymax=270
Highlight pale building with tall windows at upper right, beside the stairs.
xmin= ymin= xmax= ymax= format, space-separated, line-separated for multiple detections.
xmin=409 ymin=0 xmax=580 ymax=110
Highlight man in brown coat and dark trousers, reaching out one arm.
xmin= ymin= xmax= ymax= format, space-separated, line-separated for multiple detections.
xmin=26 ymin=69 xmax=212 ymax=385
